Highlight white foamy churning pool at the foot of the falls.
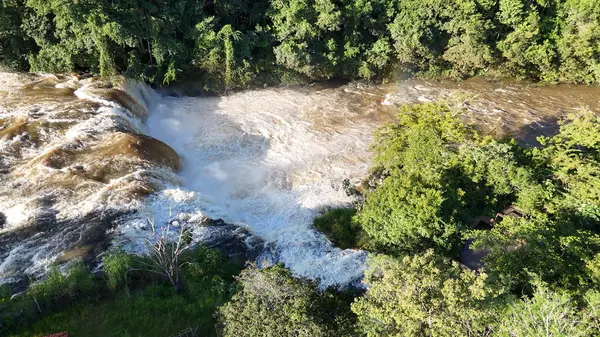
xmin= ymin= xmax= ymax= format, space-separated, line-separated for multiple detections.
xmin=142 ymin=89 xmax=394 ymax=286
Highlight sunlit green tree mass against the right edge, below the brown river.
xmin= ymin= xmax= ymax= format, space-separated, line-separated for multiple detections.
xmin=460 ymin=111 xmax=600 ymax=298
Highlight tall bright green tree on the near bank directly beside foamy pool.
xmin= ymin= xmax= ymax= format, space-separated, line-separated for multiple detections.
xmin=357 ymin=104 xmax=471 ymax=251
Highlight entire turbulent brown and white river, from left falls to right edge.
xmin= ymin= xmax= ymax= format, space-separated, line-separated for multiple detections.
xmin=0 ymin=73 xmax=600 ymax=286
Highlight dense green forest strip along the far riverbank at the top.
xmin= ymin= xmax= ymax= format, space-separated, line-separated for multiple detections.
xmin=0 ymin=0 xmax=600 ymax=93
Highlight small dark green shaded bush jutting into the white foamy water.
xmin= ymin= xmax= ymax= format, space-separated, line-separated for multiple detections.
xmin=313 ymin=208 xmax=366 ymax=249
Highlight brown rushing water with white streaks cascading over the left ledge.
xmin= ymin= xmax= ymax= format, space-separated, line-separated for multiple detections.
xmin=0 ymin=73 xmax=181 ymax=283
